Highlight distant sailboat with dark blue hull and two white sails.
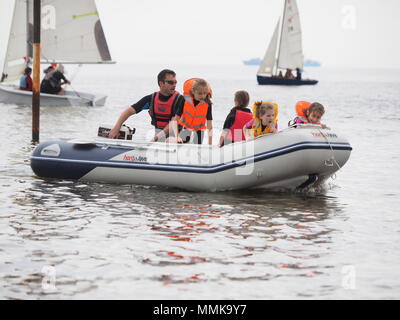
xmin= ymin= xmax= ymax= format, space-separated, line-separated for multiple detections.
xmin=257 ymin=0 xmax=318 ymax=85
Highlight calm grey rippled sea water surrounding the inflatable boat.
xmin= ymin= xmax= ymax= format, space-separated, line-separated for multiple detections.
xmin=0 ymin=65 xmax=400 ymax=299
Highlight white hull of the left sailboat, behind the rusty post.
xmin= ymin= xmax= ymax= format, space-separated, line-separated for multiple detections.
xmin=0 ymin=85 xmax=107 ymax=107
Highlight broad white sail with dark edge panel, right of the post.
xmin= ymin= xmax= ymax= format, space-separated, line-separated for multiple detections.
xmin=41 ymin=0 xmax=111 ymax=63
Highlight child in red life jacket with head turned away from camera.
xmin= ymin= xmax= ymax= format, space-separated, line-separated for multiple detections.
xmin=219 ymin=90 xmax=253 ymax=147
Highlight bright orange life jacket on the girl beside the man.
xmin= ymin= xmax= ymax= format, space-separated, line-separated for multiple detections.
xmin=178 ymin=78 xmax=212 ymax=131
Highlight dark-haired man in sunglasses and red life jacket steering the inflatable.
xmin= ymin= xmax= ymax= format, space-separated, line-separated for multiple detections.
xmin=108 ymin=69 xmax=185 ymax=141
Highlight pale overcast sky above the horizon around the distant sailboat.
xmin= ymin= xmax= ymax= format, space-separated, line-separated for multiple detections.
xmin=96 ymin=0 xmax=400 ymax=68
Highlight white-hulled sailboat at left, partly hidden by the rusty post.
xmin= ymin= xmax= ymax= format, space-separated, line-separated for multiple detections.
xmin=0 ymin=0 xmax=114 ymax=106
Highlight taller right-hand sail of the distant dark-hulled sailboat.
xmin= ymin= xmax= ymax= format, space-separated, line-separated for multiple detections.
xmin=278 ymin=0 xmax=304 ymax=70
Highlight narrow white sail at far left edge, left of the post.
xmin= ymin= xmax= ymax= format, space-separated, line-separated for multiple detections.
xmin=1 ymin=0 xmax=27 ymax=81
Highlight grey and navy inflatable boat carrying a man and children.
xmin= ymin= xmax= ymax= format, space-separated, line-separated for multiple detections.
xmin=30 ymin=125 xmax=352 ymax=192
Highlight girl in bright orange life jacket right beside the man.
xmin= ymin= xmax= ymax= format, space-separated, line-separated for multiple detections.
xmin=169 ymin=78 xmax=212 ymax=144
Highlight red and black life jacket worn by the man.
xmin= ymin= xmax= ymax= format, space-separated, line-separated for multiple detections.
xmin=149 ymin=91 xmax=179 ymax=129
